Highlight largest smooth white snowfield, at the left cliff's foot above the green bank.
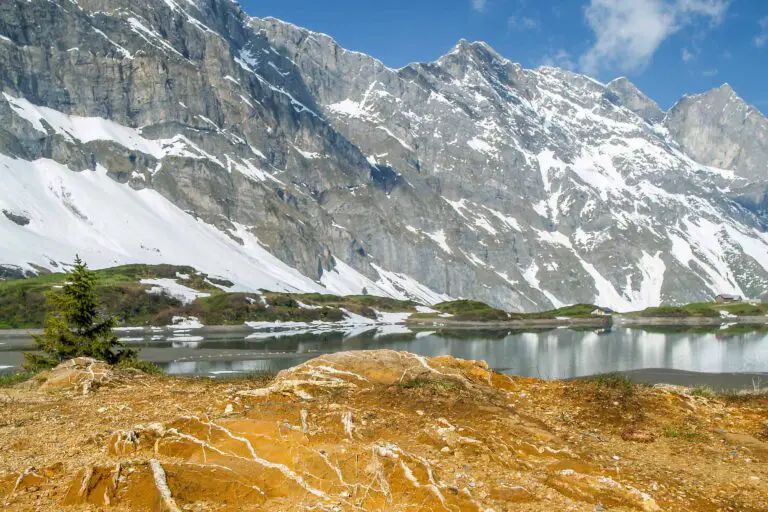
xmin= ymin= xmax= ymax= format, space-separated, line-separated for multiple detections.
xmin=0 ymin=155 xmax=325 ymax=292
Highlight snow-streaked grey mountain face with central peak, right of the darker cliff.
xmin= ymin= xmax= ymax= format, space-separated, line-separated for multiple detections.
xmin=251 ymin=19 xmax=768 ymax=308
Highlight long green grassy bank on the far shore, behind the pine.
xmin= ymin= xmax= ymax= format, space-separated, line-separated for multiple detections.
xmin=0 ymin=265 xmax=612 ymax=329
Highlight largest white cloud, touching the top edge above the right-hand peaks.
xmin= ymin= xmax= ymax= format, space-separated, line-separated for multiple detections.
xmin=579 ymin=0 xmax=730 ymax=74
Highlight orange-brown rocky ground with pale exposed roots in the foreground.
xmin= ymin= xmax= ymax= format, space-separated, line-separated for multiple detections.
xmin=0 ymin=351 xmax=768 ymax=512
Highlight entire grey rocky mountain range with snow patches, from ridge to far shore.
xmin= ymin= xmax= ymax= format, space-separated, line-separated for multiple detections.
xmin=0 ymin=0 xmax=768 ymax=311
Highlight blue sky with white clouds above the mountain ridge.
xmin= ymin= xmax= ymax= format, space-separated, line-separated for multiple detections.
xmin=241 ymin=0 xmax=768 ymax=113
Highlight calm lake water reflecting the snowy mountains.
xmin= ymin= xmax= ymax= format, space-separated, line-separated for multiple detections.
xmin=0 ymin=326 xmax=768 ymax=386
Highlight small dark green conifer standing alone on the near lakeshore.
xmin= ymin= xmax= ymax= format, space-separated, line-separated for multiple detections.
xmin=24 ymin=256 xmax=136 ymax=370
